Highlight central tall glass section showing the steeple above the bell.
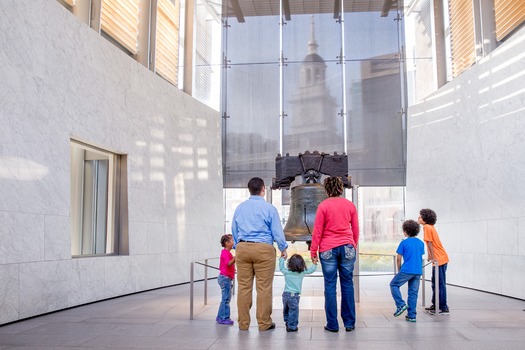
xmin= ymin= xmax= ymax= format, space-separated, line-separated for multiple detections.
xmin=283 ymin=13 xmax=344 ymax=155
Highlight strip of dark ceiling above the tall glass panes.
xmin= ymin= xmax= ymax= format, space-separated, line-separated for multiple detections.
xmin=223 ymin=0 xmax=403 ymax=23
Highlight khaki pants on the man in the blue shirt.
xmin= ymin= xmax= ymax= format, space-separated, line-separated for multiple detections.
xmin=235 ymin=242 xmax=276 ymax=330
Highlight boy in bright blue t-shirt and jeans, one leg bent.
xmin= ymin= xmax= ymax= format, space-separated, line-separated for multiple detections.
xmin=390 ymin=220 xmax=425 ymax=322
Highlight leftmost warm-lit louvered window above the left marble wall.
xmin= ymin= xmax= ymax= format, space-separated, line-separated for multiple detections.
xmin=100 ymin=0 xmax=139 ymax=54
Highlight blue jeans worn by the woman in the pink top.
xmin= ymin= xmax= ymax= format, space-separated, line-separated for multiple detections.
xmin=319 ymin=244 xmax=356 ymax=330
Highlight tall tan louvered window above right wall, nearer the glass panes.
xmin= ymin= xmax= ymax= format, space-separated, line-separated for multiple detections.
xmin=449 ymin=0 xmax=476 ymax=77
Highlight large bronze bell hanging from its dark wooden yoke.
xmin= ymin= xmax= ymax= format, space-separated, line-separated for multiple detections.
xmin=272 ymin=151 xmax=350 ymax=248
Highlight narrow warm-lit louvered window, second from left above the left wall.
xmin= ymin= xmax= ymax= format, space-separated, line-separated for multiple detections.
xmin=155 ymin=0 xmax=180 ymax=85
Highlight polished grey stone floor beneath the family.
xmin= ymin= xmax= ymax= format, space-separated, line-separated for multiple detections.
xmin=0 ymin=276 xmax=525 ymax=350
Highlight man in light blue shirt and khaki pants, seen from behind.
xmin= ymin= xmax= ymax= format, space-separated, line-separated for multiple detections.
xmin=232 ymin=177 xmax=288 ymax=331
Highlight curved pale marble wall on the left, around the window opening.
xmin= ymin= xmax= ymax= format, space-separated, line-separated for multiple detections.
xmin=0 ymin=0 xmax=224 ymax=324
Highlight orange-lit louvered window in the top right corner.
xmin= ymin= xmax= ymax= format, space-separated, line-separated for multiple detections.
xmin=494 ymin=0 xmax=525 ymax=41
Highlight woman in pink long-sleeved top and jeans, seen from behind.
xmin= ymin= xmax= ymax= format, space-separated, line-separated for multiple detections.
xmin=310 ymin=176 xmax=359 ymax=332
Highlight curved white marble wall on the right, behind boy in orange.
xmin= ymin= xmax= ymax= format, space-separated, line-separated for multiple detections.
xmin=407 ymin=28 xmax=525 ymax=300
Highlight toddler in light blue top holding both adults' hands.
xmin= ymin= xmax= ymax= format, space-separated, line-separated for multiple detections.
xmin=279 ymin=254 xmax=317 ymax=332
